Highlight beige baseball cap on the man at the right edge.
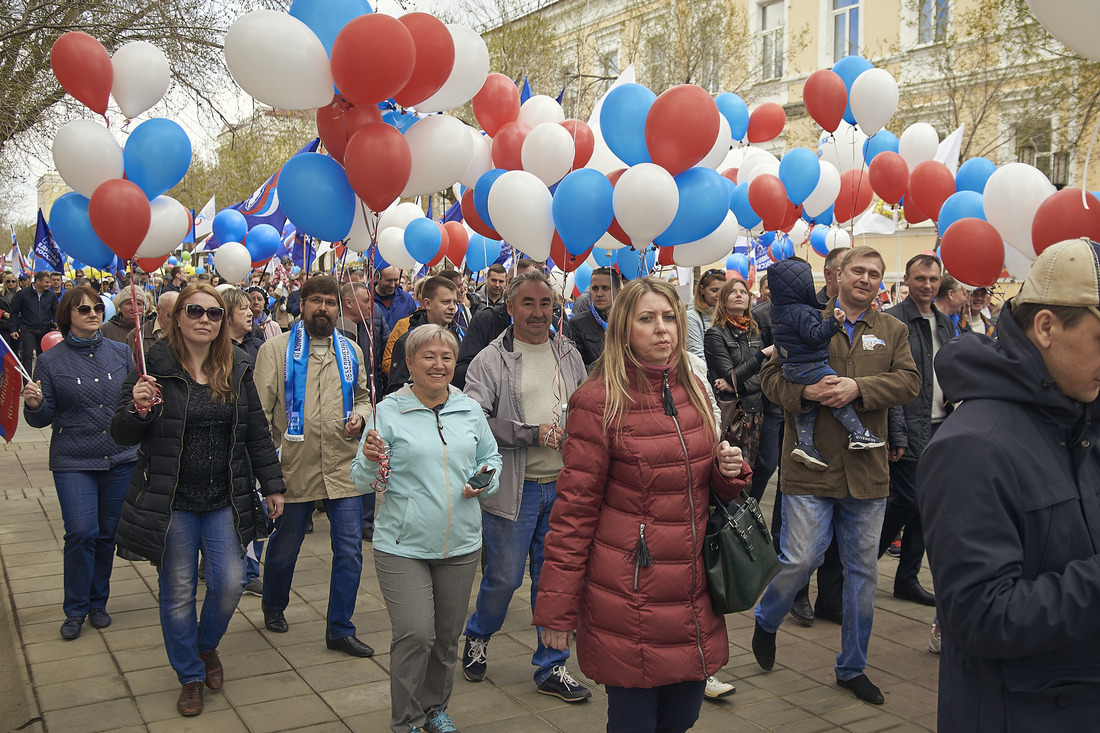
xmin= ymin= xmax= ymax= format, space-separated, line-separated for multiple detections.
xmin=1014 ymin=238 xmax=1100 ymax=318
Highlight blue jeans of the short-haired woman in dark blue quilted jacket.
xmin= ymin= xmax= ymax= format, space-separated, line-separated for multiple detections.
xmin=54 ymin=461 xmax=134 ymax=617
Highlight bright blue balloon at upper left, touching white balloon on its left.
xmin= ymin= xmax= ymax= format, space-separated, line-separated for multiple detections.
xmin=122 ymin=118 xmax=191 ymax=200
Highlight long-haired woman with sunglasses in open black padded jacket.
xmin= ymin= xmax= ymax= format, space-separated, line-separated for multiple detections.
xmin=111 ymin=283 xmax=286 ymax=715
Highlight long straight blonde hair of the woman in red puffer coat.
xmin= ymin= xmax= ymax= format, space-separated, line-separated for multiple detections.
xmin=592 ymin=277 xmax=717 ymax=441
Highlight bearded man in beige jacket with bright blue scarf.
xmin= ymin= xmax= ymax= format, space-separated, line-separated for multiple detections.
xmin=255 ymin=275 xmax=374 ymax=657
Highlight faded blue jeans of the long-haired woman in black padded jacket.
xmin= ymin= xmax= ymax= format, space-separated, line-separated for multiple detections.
xmin=160 ymin=506 xmax=244 ymax=685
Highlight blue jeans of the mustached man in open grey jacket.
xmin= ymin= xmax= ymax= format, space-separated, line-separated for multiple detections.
xmin=465 ymin=481 xmax=569 ymax=685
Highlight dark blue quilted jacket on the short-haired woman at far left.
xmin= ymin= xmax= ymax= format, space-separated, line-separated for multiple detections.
xmin=23 ymin=338 xmax=138 ymax=471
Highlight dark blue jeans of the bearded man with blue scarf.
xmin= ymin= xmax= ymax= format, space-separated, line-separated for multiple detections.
xmin=263 ymin=495 xmax=363 ymax=639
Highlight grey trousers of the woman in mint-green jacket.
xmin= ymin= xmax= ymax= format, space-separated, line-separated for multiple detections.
xmin=374 ymin=550 xmax=481 ymax=733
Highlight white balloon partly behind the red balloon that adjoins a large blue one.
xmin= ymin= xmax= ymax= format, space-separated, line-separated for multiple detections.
xmin=402 ymin=114 xmax=474 ymax=196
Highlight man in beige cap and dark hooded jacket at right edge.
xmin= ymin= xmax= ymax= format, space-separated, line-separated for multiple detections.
xmin=917 ymin=240 xmax=1100 ymax=733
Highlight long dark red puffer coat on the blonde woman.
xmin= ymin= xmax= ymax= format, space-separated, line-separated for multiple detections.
xmin=534 ymin=369 xmax=750 ymax=688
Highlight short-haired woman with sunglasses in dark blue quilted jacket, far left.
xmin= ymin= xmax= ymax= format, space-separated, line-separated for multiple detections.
xmin=23 ymin=285 xmax=138 ymax=639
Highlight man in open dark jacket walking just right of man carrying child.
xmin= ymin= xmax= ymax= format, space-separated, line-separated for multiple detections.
xmin=879 ymin=254 xmax=955 ymax=605
